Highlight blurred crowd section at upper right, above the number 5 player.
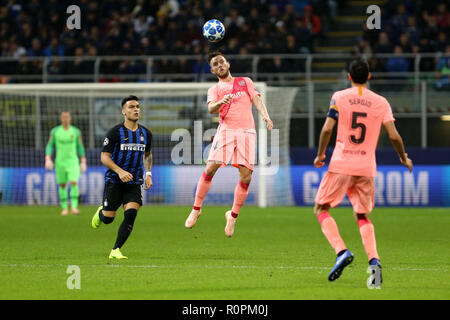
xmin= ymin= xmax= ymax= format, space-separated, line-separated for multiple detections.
xmin=355 ymin=0 xmax=450 ymax=89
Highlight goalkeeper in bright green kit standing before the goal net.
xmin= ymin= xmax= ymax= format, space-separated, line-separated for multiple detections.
xmin=45 ymin=111 xmax=86 ymax=216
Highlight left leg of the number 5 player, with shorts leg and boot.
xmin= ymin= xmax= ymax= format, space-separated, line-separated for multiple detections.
xmin=314 ymin=172 xmax=353 ymax=281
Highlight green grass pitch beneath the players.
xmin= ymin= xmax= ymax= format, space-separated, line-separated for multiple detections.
xmin=0 ymin=206 xmax=450 ymax=300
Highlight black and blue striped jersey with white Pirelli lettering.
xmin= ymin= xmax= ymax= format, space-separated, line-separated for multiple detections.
xmin=102 ymin=123 xmax=152 ymax=184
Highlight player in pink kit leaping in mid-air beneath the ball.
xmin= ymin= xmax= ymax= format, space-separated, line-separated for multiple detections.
xmin=185 ymin=52 xmax=273 ymax=237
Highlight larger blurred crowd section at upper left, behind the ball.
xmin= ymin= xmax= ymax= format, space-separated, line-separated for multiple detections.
xmin=0 ymin=0 xmax=343 ymax=81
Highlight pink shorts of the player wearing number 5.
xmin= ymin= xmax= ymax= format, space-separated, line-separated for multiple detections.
xmin=316 ymin=172 xmax=375 ymax=214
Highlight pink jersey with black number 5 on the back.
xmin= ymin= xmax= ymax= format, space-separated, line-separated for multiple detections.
xmin=328 ymin=87 xmax=395 ymax=177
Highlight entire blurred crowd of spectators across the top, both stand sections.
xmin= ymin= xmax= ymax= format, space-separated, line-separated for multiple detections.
xmin=0 ymin=0 xmax=450 ymax=86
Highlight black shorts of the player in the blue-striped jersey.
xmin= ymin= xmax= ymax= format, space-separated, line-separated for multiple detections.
xmin=103 ymin=182 xmax=142 ymax=211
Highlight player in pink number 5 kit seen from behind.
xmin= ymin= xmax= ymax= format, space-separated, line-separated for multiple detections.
xmin=314 ymin=59 xmax=413 ymax=285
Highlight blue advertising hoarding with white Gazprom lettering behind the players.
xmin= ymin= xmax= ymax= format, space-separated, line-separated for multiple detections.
xmin=0 ymin=165 xmax=450 ymax=207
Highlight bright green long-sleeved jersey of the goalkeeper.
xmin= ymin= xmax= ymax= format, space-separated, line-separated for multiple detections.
xmin=45 ymin=125 xmax=85 ymax=167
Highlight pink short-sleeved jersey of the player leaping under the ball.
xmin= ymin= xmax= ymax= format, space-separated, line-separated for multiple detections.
xmin=206 ymin=77 xmax=259 ymax=130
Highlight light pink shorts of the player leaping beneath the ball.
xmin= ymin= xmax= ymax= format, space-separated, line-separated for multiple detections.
xmin=208 ymin=129 xmax=256 ymax=170
